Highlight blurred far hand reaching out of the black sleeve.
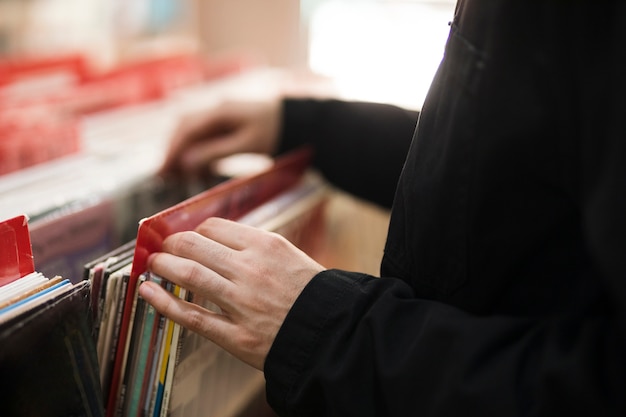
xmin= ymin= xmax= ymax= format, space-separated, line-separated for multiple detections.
xmin=160 ymin=98 xmax=281 ymax=177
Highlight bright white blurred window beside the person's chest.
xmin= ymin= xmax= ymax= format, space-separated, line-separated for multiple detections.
xmin=309 ymin=0 xmax=455 ymax=109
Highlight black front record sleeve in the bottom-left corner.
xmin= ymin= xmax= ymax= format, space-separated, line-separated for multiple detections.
xmin=0 ymin=281 xmax=104 ymax=417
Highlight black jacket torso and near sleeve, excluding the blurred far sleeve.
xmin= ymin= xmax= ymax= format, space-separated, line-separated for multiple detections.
xmin=265 ymin=0 xmax=626 ymax=416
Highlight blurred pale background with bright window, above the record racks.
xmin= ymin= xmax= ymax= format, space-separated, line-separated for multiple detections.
xmin=0 ymin=0 xmax=454 ymax=108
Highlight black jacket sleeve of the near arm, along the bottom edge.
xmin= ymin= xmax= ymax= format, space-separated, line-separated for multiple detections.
xmin=265 ymin=270 xmax=626 ymax=417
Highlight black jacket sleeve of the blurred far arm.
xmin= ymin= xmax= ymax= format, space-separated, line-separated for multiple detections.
xmin=279 ymin=99 xmax=418 ymax=208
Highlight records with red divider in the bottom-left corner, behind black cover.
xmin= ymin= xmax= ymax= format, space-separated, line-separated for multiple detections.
xmin=0 ymin=216 xmax=104 ymax=416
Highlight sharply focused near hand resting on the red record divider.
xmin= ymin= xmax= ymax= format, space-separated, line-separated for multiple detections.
xmin=139 ymin=218 xmax=324 ymax=370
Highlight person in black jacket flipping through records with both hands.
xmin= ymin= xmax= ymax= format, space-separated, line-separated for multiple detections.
xmin=140 ymin=0 xmax=626 ymax=416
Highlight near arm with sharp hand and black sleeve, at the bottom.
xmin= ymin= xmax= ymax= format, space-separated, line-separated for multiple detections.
xmin=140 ymin=206 xmax=626 ymax=416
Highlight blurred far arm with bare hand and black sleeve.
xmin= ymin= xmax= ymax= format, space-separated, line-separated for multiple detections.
xmin=161 ymin=99 xmax=418 ymax=207
